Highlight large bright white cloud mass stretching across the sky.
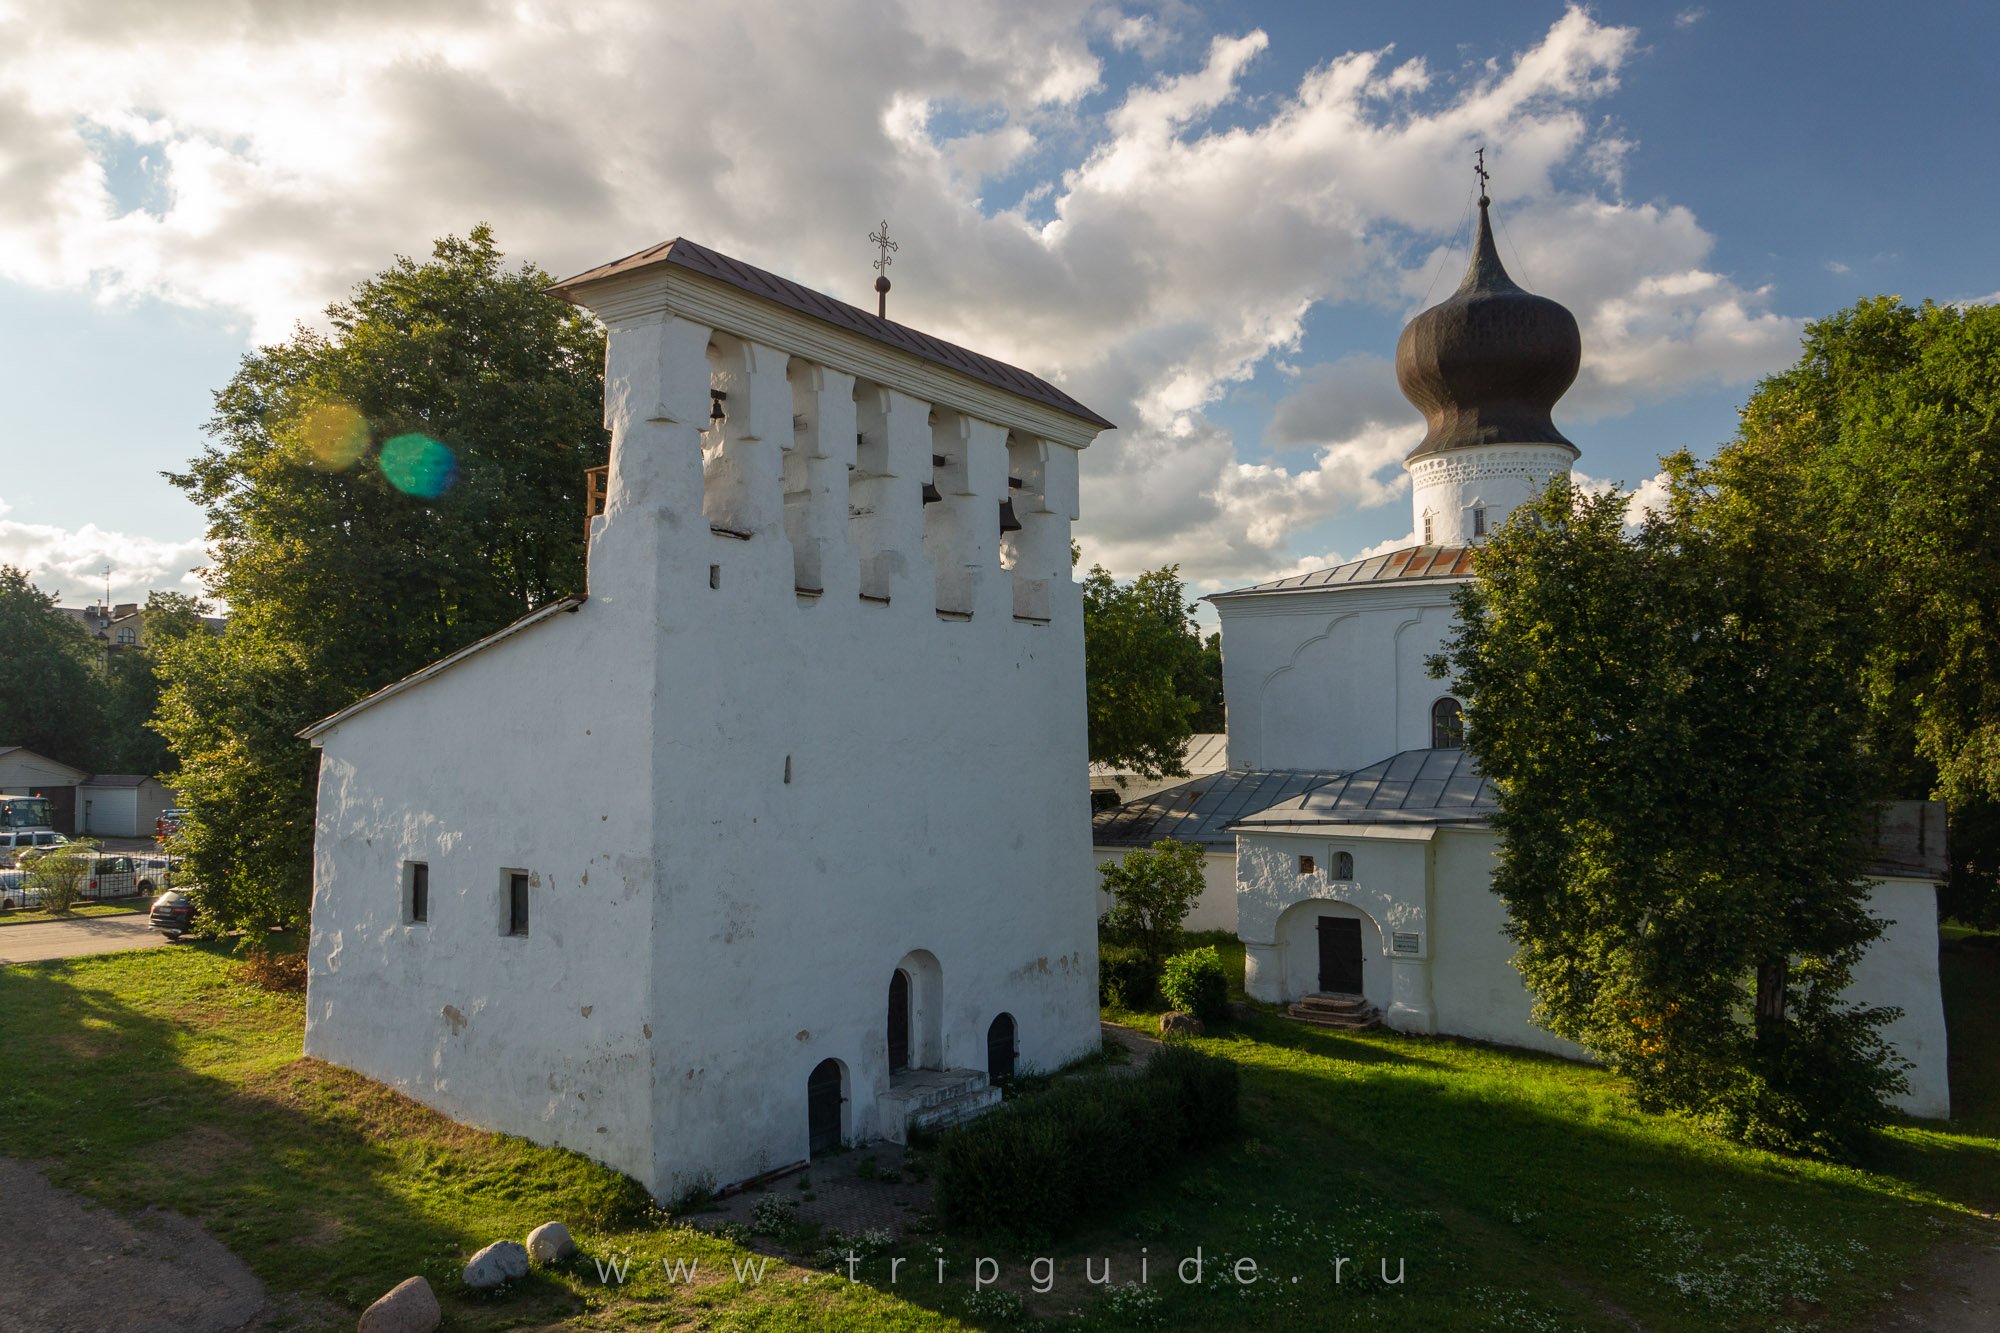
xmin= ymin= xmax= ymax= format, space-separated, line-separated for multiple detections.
xmin=0 ymin=0 xmax=1798 ymax=580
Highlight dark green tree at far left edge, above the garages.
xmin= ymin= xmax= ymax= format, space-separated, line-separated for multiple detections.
xmin=0 ymin=564 xmax=106 ymax=769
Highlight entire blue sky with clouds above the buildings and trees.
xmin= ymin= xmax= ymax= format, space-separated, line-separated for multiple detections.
xmin=0 ymin=0 xmax=2000 ymax=602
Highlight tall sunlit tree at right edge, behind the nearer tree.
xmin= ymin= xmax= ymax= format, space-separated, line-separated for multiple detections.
xmin=1706 ymin=296 xmax=2000 ymax=927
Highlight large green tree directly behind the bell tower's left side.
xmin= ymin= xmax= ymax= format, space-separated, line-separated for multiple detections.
xmin=160 ymin=226 xmax=608 ymax=925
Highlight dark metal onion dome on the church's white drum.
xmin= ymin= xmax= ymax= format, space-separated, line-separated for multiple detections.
xmin=1396 ymin=196 xmax=1584 ymax=462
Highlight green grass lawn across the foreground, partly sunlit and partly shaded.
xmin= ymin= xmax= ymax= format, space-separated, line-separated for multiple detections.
xmin=0 ymin=943 xmax=2000 ymax=1333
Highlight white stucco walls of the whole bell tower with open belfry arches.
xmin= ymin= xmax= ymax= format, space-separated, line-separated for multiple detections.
xmin=306 ymin=246 xmax=1100 ymax=1197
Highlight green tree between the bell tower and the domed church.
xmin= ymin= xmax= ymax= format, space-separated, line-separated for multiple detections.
xmin=1084 ymin=564 xmax=1222 ymax=777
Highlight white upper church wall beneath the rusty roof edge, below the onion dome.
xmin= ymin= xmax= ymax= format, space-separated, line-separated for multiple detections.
xmin=1216 ymin=582 xmax=1452 ymax=771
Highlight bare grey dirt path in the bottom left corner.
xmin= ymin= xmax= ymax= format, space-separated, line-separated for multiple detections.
xmin=0 ymin=1157 xmax=264 ymax=1333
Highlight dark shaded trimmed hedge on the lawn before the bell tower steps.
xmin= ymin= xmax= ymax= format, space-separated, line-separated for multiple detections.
xmin=930 ymin=1047 xmax=1240 ymax=1241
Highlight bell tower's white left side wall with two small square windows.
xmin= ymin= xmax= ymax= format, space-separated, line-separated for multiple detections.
xmin=306 ymin=604 xmax=654 ymax=1181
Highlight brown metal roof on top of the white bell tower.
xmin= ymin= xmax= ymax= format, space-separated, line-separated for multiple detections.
xmin=548 ymin=236 xmax=1114 ymax=430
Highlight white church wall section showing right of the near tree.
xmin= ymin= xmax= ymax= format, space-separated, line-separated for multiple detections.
xmin=1846 ymin=879 xmax=1952 ymax=1121
